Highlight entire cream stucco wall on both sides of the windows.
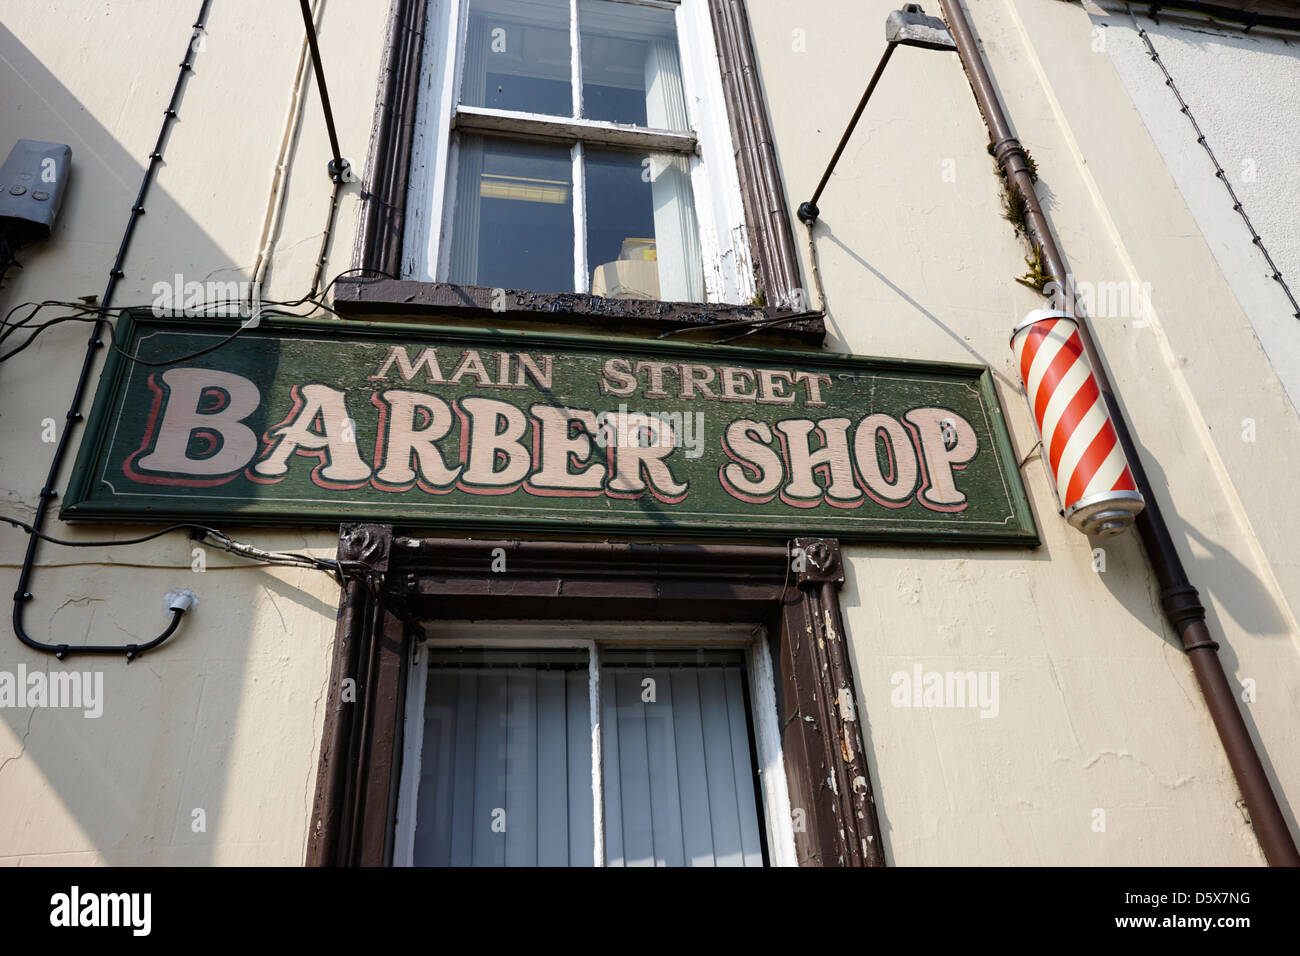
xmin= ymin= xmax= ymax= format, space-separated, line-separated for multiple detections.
xmin=0 ymin=0 xmax=1300 ymax=865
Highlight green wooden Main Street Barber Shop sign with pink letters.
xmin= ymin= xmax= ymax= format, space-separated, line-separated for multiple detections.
xmin=62 ymin=313 xmax=1037 ymax=545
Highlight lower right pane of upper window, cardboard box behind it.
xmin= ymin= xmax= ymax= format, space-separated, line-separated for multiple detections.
xmin=585 ymin=148 xmax=705 ymax=302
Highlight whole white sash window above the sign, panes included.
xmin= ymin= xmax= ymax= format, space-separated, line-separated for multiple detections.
xmin=403 ymin=0 xmax=757 ymax=303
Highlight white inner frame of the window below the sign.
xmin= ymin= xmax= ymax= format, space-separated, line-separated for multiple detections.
xmin=393 ymin=620 xmax=798 ymax=866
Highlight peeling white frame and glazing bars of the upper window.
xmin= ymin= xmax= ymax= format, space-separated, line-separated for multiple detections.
xmin=402 ymin=0 xmax=758 ymax=304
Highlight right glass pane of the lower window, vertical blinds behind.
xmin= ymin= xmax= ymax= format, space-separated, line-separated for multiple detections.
xmin=601 ymin=652 xmax=763 ymax=866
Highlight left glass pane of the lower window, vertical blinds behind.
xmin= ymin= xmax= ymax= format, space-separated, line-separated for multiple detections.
xmin=413 ymin=650 xmax=594 ymax=866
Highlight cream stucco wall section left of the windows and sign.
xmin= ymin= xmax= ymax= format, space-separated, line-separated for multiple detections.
xmin=0 ymin=0 xmax=386 ymax=865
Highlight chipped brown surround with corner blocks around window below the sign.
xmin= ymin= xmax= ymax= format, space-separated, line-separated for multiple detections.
xmin=306 ymin=524 xmax=884 ymax=866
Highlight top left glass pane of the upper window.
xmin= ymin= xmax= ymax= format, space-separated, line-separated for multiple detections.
xmin=460 ymin=0 xmax=573 ymax=116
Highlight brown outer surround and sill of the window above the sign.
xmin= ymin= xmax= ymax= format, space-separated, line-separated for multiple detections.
xmin=334 ymin=0 xmax=826 ymax=346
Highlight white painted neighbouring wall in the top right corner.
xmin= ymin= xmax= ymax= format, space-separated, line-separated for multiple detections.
xmin=1092 ymin=6 xmax=1300 ymax=407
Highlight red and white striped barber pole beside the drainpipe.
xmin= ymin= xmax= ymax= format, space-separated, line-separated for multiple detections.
xmin=1011 ymin=308 xmax=1145 ymax=536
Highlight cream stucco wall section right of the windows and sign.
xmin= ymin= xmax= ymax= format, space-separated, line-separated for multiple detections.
xmin=751 ymin=0 xmax=1300 ymax=864
